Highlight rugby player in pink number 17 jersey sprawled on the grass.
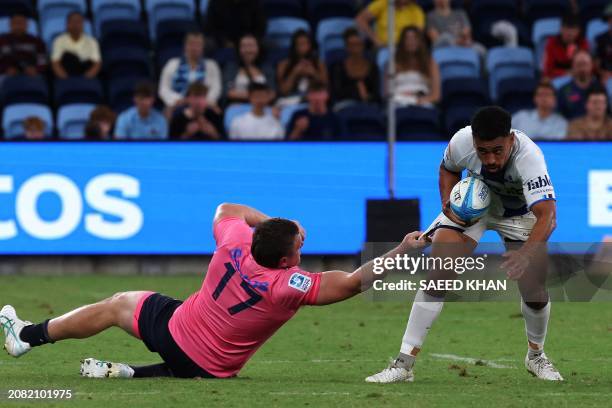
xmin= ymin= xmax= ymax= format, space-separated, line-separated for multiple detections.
xmin=0 ymin=204 xmax=425 ymax=378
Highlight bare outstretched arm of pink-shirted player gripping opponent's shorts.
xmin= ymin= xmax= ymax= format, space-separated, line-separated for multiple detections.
xmin=316 ymin=231 xmax=427 ymax=306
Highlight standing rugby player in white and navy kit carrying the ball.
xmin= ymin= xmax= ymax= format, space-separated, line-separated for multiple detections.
xmin=366 ymin=106 xmax=563 ymax=383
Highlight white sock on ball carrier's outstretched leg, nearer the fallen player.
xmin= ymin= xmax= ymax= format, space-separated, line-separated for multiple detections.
xmin=395 ymin=290 xmax=444 ymax=369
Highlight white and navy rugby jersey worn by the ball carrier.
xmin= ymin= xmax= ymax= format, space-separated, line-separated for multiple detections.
xmin=442 ymin=126 xmax=556 ymax=217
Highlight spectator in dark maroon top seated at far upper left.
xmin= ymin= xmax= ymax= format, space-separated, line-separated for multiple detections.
xmin=0 ymin=14 xmax=47 ymax=83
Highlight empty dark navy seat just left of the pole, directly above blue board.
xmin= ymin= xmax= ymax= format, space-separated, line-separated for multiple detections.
xmin=336 ymin=103 xmax=387 ymax=140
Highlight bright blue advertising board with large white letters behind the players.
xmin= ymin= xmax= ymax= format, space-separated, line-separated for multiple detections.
xmin=0 ymin=142 xmax=612 ymax=254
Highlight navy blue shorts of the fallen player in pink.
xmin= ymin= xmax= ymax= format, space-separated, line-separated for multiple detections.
xmin=138 ymin=293 xmax=215 ymax=378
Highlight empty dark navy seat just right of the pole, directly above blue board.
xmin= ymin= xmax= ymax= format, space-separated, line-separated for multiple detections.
xmin=396 ymin=106 xmax=442 ymax=140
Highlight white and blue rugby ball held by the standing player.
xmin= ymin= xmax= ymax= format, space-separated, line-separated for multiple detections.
xmin=450 ymin=177 xmax=491 ymax=223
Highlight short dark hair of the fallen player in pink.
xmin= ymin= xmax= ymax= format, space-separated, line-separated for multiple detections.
xmin=251 ymin=218 xmax=299 ymax=268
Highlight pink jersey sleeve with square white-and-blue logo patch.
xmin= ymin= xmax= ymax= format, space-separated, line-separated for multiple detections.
xmin=274 ymin=268 xmax=321 ymax=310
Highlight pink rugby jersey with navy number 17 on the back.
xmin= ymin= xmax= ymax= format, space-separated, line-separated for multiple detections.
xmin=168 ymin=217 xmax=321 ymax=377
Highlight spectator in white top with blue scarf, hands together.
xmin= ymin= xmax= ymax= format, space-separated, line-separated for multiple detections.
xmin=159 ymin=32 xmax=222 ymax=111
